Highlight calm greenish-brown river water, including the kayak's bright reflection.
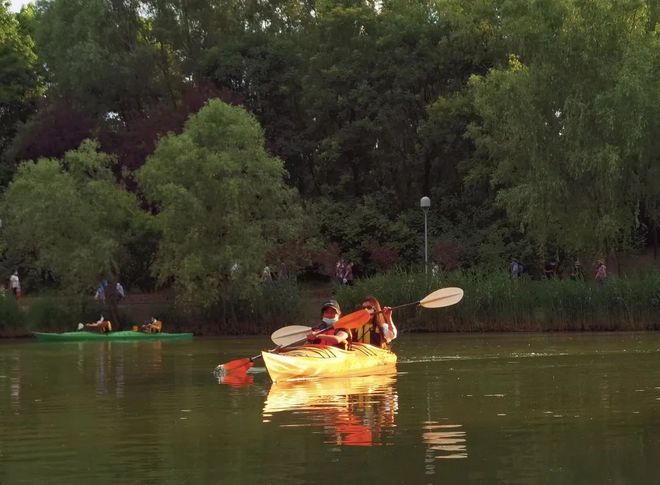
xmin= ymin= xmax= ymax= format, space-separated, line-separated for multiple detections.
xmin=0 ymin=333 xmax=660 ymax=484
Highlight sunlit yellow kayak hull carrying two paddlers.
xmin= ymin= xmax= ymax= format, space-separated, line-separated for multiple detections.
xmin=261 ymin=343 xmax=396 ymax=382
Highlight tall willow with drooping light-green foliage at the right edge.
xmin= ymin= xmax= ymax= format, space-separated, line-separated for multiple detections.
xmin=471 ymin=0 xmax=660 ymax=254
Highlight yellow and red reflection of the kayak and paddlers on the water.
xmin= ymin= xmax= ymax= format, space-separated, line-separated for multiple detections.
xmin=263 ymin=373 xmax=399 ymax=446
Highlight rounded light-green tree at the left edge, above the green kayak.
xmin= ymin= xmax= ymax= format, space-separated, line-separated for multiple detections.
xmin=0 ymin=140 xmax=146 ymax=320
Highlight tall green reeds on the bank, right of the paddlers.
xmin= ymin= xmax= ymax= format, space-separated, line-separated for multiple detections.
xmin=337 ymin=270 xmax=660 ymax=332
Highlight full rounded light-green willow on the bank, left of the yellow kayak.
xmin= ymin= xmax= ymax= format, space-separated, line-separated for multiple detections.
xmin=138 ymin=100 xmax=301 ymax=308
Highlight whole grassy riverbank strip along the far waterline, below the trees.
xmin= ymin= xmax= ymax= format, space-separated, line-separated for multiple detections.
xmin=0 ymin=271 xmax=660 ymax=337
